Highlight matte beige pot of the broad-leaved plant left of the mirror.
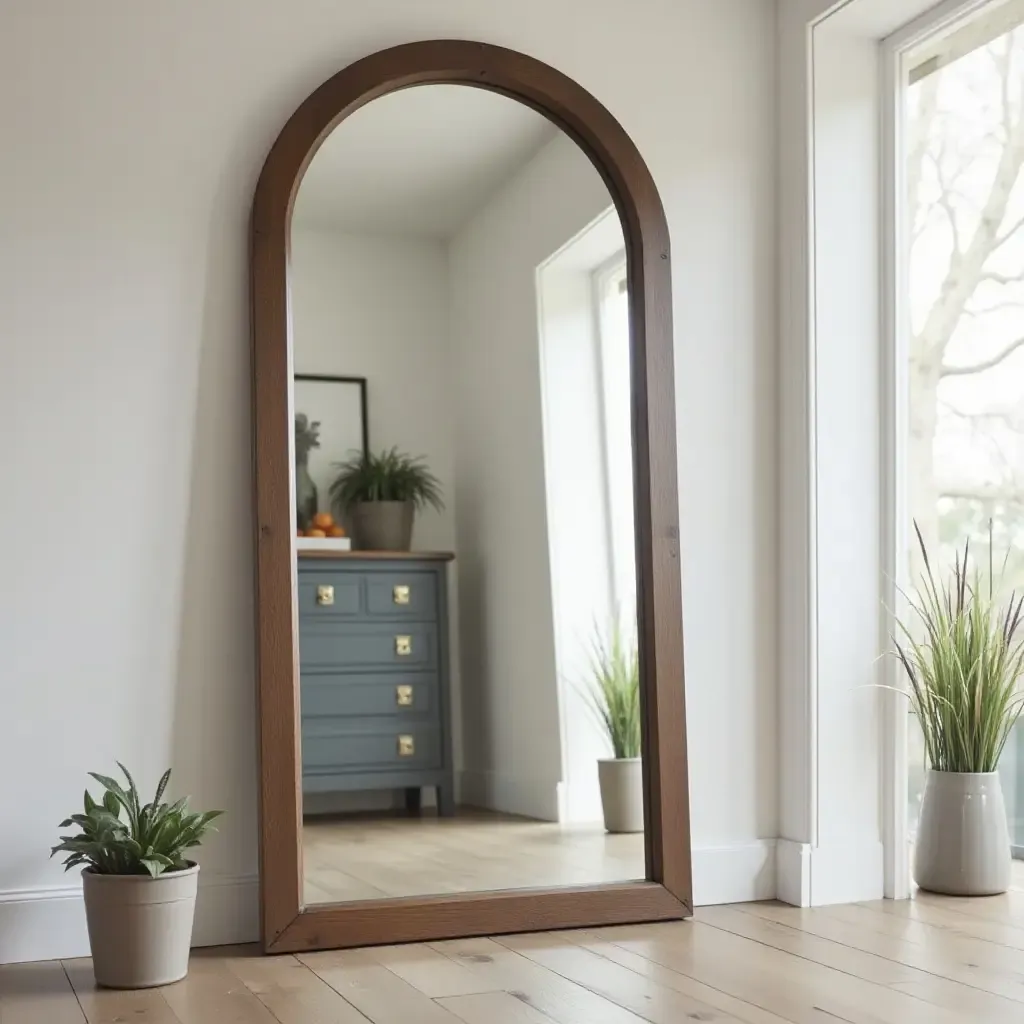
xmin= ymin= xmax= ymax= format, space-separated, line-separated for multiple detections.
xmin=82 ymin=864 xmax=199 ymax=988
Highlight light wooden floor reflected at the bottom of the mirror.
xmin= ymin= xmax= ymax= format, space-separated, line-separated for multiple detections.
xmin=302 ymin=808 xmax=646 ymax=903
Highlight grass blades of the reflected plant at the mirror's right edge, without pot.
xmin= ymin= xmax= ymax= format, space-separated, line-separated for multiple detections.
xmin=588 ymin=623 xmax=640 ymax=759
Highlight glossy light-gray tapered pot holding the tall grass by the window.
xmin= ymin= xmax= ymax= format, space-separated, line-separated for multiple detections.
xmin=913 ymin=771 xmax=1011 ymax=896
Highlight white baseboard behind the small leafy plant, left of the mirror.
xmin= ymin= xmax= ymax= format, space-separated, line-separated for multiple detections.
xmin=0 ymin=874 xmax=259 ymax=964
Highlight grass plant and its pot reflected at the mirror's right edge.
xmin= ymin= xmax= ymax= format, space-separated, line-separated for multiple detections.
xmin=589 ymin=623 xmax=643 ymax=833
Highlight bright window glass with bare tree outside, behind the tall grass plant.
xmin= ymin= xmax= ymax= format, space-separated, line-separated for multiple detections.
xmin=902 ymin=2 xmax=1024 ymax=856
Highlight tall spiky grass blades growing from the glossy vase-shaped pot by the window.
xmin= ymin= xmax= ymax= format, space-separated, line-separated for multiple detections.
xmin=893 ymin=523 xmax=1024 ymax=772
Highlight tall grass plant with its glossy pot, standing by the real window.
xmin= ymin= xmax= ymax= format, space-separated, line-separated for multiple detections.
xmin=895 ymin=524 xmax=1024 ymax=896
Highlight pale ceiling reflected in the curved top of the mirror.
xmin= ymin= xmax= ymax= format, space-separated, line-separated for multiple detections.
xmin=294 ymin=85 xmax=558 ymax=239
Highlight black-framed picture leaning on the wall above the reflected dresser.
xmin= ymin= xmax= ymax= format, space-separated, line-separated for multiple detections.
xmin=293 ymin=374 xmax=370 ymax=528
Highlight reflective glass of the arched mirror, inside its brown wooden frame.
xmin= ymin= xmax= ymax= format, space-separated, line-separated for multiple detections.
xmin=290 ymin=85 xmax=645 ymax=904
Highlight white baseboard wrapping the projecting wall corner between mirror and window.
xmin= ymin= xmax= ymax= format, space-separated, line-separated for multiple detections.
xmin=776 ymin=840 xmax=885 ymax=906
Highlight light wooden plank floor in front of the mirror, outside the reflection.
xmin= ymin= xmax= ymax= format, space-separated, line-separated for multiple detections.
xmin=12 ymin=864 xmax=1024 ymax=1024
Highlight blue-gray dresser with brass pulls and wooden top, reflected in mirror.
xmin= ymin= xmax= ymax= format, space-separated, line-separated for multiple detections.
xmin=298 ymin=551 xmax=455 ymax=815
